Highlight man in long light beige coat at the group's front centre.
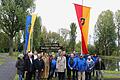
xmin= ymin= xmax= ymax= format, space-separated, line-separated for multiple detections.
xmin=56 ymin=52 xmax=66 ymax=80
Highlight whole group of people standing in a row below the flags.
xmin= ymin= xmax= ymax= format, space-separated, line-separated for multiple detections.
xmin=16 ymin=50 xmax=105 ymax=80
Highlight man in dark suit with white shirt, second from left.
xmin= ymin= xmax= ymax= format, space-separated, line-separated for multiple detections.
xmin=25 ymin=52 xmax=34 ymax=80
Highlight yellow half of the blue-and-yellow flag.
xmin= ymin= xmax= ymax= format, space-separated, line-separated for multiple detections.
xmin=27 ymin=14 xmax=37 ymax=51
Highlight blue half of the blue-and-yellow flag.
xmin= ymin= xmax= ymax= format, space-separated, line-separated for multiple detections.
xmin=25 ymin=15 xmax=32 ymax=53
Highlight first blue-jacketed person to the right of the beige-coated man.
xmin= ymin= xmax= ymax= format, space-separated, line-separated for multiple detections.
xmin=68 ymin=53 xmax=77 ymax=80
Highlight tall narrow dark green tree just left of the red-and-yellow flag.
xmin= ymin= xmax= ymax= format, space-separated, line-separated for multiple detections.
xmin=69 ymin=23 xmax=77 ymax=51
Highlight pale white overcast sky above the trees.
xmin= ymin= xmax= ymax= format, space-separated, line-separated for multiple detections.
xmin=35 ymin=0 xmax=120 ymax=44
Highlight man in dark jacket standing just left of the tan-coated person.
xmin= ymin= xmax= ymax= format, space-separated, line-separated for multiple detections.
xmin=34 ymin=54 xmax=45 ymax=80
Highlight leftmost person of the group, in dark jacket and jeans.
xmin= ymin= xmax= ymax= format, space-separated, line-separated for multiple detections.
xmin=16 ymin=54 xmax=24 ymax=80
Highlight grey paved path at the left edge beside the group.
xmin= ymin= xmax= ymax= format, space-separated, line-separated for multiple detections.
xmin=0 ymin=54 xmax=16 ymax=80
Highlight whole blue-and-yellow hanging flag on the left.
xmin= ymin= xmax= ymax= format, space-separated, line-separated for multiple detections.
xmin=25 ymin=14 xmax=36 ymax=53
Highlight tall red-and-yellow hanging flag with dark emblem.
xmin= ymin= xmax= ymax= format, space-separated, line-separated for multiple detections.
xmin=74 ymin=4 xmax=90 ymax=54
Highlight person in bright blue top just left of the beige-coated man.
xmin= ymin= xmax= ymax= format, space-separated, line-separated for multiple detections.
xmin=48 ymin=55 xmax=56 ymax=80
